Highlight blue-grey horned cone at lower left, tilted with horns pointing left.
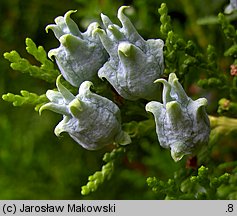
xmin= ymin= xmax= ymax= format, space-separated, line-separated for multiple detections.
xmin=39 ymin=77 xmax=131 ymax=150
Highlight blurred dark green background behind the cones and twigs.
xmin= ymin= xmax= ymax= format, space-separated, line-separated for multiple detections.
xmin=0 ymin=0 xmax=233 ymax=199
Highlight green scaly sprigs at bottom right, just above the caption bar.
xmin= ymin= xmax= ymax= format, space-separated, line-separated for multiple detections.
xmin=147 ymin=166 xmax=230 ymax=199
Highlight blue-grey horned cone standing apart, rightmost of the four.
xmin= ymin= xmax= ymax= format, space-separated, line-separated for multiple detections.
xmin=146 ymin=73 xmax=210 ymax=161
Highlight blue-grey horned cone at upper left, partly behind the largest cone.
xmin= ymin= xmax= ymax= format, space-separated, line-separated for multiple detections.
xmin=46 ymin=11 xmax=108 ymax=87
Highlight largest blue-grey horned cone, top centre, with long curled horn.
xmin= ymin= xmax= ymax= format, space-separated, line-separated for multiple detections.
xmin=95 ymin=6 xmax=164 ymax=100
